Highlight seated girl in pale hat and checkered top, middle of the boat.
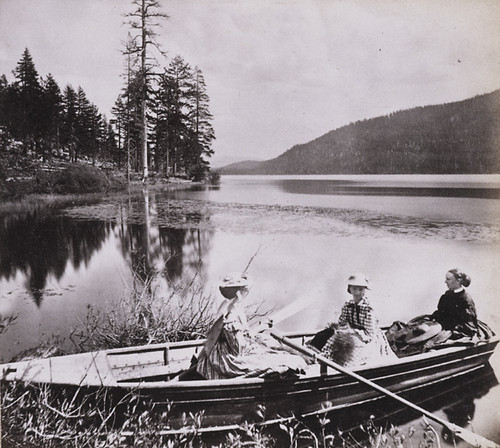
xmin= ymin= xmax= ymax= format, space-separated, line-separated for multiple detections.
xmin=321 ymin=274 xmax=397 ymax=367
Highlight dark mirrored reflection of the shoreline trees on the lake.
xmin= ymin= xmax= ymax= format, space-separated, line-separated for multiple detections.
xmin=0 ymin=190 xmax=212 ymax=306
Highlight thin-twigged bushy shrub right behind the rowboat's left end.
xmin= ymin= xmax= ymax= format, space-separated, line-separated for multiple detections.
xmin=70 ymin=272 xmax=215 ymax=351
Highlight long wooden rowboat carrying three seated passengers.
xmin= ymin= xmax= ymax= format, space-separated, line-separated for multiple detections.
xmin=0 ymin=333 xmax=499 ymax=431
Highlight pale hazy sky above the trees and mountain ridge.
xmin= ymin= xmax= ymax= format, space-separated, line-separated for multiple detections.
xmin=0 ymin=0 xmax=500 ymax=165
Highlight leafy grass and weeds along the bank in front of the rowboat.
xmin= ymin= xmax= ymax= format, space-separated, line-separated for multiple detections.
xmin=2 ymin=384 xmax=440 ymax=448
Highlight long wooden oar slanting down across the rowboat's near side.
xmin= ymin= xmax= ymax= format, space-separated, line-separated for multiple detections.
xmin=270 ymin=329 xmax=500 ymax=448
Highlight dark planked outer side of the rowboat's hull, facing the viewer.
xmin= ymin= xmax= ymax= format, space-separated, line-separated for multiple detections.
xmin=119 ymin=342 xmax=497 ymax=429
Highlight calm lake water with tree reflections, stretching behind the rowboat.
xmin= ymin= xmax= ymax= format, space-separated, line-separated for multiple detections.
xmin=0 ymin=175 xmax=500 ymax=442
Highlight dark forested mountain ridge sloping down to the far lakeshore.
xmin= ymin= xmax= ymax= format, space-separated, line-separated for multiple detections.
xmin=220 ymin=90 xmax=500 ymax=174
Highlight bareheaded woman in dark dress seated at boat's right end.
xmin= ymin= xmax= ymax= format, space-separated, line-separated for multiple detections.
xmin=431 ymin=269 xmax=479 ymax=339
